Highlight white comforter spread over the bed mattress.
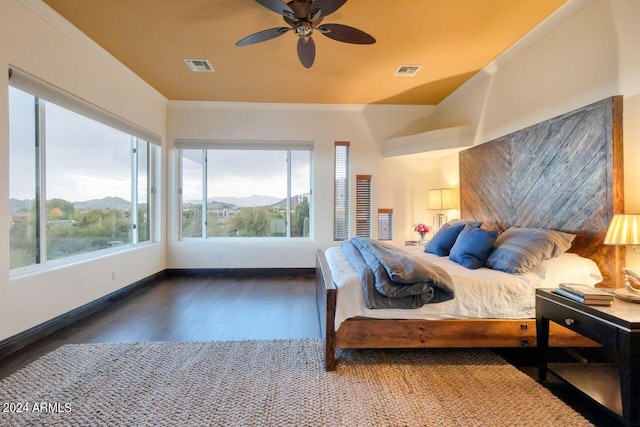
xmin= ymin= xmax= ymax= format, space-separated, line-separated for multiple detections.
xmin=325 ymin=246 xmax=602 ymax=330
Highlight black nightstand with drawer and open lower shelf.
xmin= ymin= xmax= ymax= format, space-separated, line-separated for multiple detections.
xmin=536 ymin=289 xmax=640 ymax=426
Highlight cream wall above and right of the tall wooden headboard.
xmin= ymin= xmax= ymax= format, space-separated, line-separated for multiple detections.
xmin=437 ymin=0 xmax=640 ymax=268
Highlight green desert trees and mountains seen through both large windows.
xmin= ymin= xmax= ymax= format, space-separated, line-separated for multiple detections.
xmin=9 ymin=194 xmax=310 ymax=268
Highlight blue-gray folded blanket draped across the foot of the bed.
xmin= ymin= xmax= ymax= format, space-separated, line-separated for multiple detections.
xmin=342 ymin=237 xmax=453 ymax=308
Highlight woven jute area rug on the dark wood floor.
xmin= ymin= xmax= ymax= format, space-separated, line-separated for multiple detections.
xmin=0 ymin=340 xmax=589 ymax=427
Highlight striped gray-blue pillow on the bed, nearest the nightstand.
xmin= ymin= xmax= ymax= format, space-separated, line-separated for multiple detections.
xmin=485 ymin=227 xmax=576 ymax=273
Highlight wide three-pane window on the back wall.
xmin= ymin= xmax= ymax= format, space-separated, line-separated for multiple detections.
xmin=177 ymin=142 xmax=311 ymax=238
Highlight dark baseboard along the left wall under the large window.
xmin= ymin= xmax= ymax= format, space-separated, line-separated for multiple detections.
xmin=0 ymin=270 xmax=167 ymax=359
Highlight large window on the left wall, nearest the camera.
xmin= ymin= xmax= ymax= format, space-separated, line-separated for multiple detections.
xmin=9 ymin=70 xmax=159 ymax=269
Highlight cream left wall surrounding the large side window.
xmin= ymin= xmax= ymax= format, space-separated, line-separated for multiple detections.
xmin=0 ymin=0 xmax=167 ymax=340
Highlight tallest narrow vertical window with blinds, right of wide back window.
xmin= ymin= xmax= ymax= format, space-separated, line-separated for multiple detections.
xmin=333 ymin=142 xmax=350 ymax=240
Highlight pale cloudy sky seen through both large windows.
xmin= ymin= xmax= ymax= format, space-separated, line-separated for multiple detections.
xmin=9 ymin=87 xmax=310 ymax=202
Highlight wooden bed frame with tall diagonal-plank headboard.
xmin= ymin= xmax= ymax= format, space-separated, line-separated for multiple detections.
xmin=316 ymin=96 xmax=624 ymax=370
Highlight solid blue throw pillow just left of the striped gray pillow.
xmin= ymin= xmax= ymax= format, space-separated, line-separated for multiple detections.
xmin=449 ymin=224 xmax=498 ymax=270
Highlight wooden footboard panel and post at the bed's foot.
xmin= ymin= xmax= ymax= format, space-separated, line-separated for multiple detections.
xmin=316 ymin=249 xmax=337 ymax=371
